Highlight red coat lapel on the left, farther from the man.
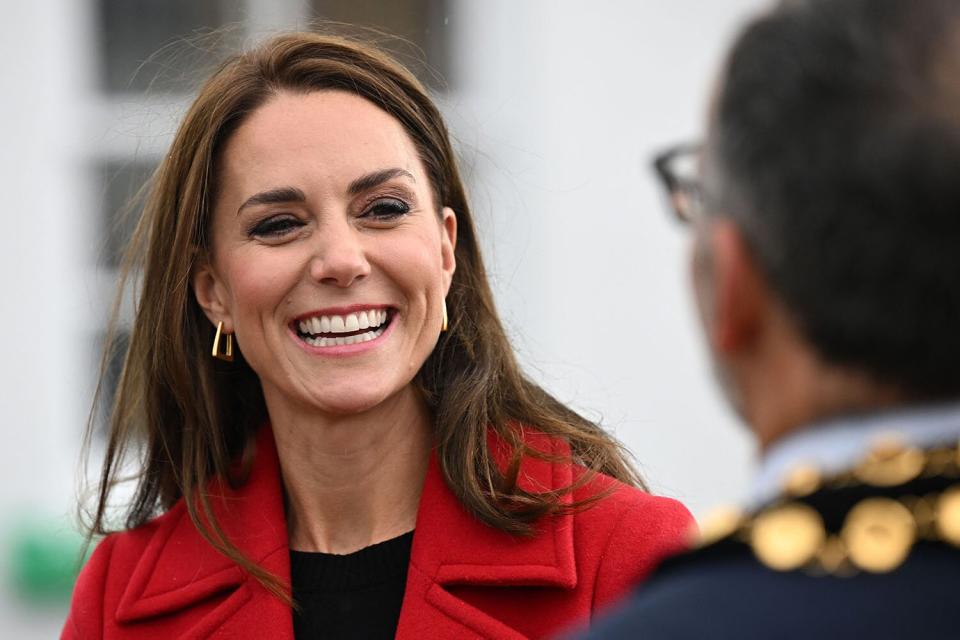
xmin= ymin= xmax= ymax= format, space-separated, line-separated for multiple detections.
xmin=117 ymin=428 xmax=293 ymax=640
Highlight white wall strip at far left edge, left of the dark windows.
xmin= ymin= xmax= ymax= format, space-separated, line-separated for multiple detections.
xmin=0 ymin=0 xmax=91 ymax=638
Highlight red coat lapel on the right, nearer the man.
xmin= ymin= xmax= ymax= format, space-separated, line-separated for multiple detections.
xmin=397 ymin=434 xmax=577 ymax=639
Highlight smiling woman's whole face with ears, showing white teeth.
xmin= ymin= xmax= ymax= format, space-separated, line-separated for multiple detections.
xmin=194 ymin=91 xmax=456 ymax=414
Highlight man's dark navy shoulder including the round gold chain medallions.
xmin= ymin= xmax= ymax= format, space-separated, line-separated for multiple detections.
xmin=590 ymin=468 xmax=960 ymax=639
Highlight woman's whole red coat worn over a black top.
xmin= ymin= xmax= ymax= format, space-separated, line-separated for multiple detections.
xmin=62 ymin=429 xmax=692 ymax=640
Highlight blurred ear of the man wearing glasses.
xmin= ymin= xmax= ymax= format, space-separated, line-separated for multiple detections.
xmin=706 ymin=219 xmax=770 ymax=355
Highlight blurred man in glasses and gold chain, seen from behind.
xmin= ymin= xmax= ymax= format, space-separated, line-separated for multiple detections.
xmin=590 ymin=0 xmax=960 ymax=640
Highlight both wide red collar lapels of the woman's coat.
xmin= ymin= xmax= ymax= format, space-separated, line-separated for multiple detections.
xmin=117 ymin=427 xmax=577 ymax=638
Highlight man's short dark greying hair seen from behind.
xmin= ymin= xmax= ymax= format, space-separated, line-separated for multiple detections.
xmin=707 ymin=0 xmax=960 ymax=399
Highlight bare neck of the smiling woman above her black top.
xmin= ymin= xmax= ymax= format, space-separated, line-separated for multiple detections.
xmin=268 ymin=387 xmax=431 ymax=554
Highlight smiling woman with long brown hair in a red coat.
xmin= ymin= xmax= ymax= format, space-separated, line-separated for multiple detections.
xmin=64 ymin=33 xmax=690 ymax=638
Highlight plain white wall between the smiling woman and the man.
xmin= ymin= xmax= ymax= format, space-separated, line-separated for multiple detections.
xmin=447 ymin=0 xmax=764 ymax=515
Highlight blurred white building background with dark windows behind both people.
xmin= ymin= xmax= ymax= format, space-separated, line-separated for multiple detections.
xmin=0 ymin=0 xmax=766 ymax=638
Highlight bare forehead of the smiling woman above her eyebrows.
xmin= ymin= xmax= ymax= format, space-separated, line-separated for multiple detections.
xmin=221 ymin=91 xmax=425 ymax=195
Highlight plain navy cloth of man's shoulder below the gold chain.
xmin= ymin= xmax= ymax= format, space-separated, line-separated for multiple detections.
xmin=589 ymin=539 xmax=960 ymax=640
